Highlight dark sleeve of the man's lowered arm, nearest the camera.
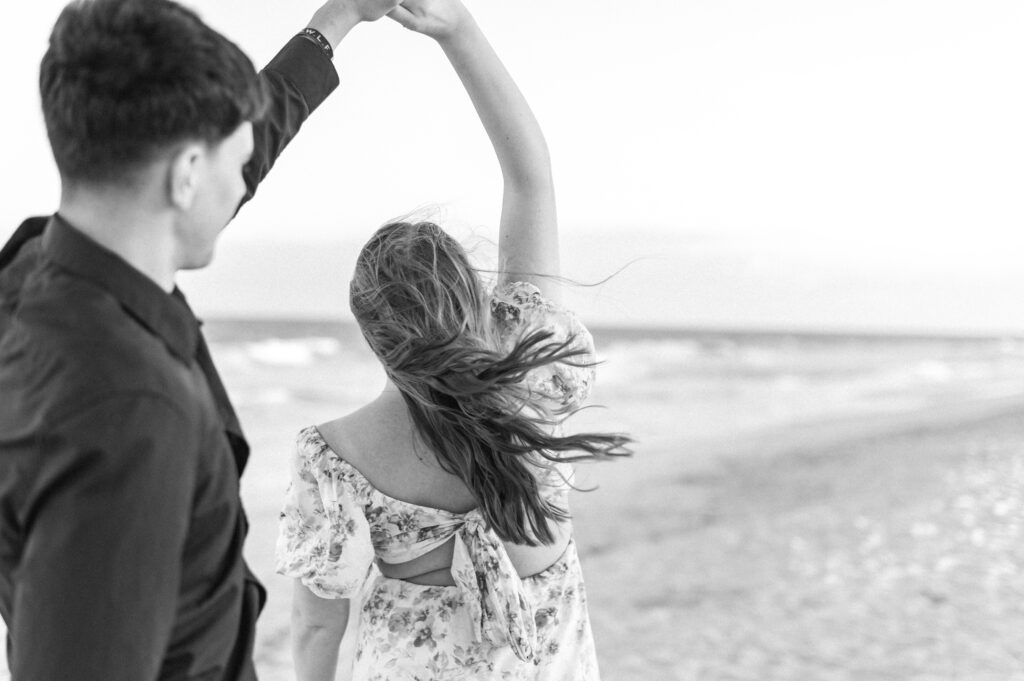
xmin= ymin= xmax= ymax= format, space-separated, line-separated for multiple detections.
xmin=8 ymin=394 xmax=198 ymax=681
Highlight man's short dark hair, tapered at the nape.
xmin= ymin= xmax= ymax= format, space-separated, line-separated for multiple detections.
xmin=39 ymin=0 xmax=267 ymax=184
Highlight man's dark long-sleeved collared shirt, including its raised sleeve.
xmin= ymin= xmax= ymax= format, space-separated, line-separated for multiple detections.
xmin=0 ymin=38 xmax=338 ymax=681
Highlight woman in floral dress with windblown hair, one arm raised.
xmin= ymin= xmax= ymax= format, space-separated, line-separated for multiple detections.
xmin=278 ymin=0 xmax=629 ymax=681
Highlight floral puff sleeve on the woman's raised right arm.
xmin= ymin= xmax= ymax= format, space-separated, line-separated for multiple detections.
xmin=490 ymin=282 xmax=596 ymax=409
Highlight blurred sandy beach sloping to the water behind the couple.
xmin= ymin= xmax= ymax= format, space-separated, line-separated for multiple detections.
xmin=235 ymin=387 xmax=1024 ymax=681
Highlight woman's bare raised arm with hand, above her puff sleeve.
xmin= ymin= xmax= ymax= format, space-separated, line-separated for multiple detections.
xmin=389 ymin=0 xmax=560 ymax=300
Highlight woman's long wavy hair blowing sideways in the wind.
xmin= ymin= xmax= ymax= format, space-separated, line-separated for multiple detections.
xmin=350 ymin=222 xmax=631 ymax=545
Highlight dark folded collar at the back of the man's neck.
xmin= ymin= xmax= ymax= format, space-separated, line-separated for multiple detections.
xmin=43 ymin=215 xmax=200 ymax=364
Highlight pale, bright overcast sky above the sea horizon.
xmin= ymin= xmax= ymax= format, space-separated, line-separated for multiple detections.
xmin=0 ymin=0 xmax=1024 ymax=330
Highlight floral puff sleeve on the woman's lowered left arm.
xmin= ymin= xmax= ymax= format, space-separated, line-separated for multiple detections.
xmin=275 ymin=428 xmax=374 ymax=598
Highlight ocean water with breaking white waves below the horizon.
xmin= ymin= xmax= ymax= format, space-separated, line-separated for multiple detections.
xmin=205 ymin=321 xmax=1024 ymax=441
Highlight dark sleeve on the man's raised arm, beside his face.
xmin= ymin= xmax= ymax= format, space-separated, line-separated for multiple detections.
xmin=239 ymin=36 xmax=339 ymax=208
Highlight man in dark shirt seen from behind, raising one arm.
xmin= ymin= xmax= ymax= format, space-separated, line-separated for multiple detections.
xmin=0 ymin=0 xmax=398 ymax=681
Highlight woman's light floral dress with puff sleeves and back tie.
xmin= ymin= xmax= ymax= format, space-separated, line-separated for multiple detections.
xmin=276 ymin=283 xmax=599 ymax=681
